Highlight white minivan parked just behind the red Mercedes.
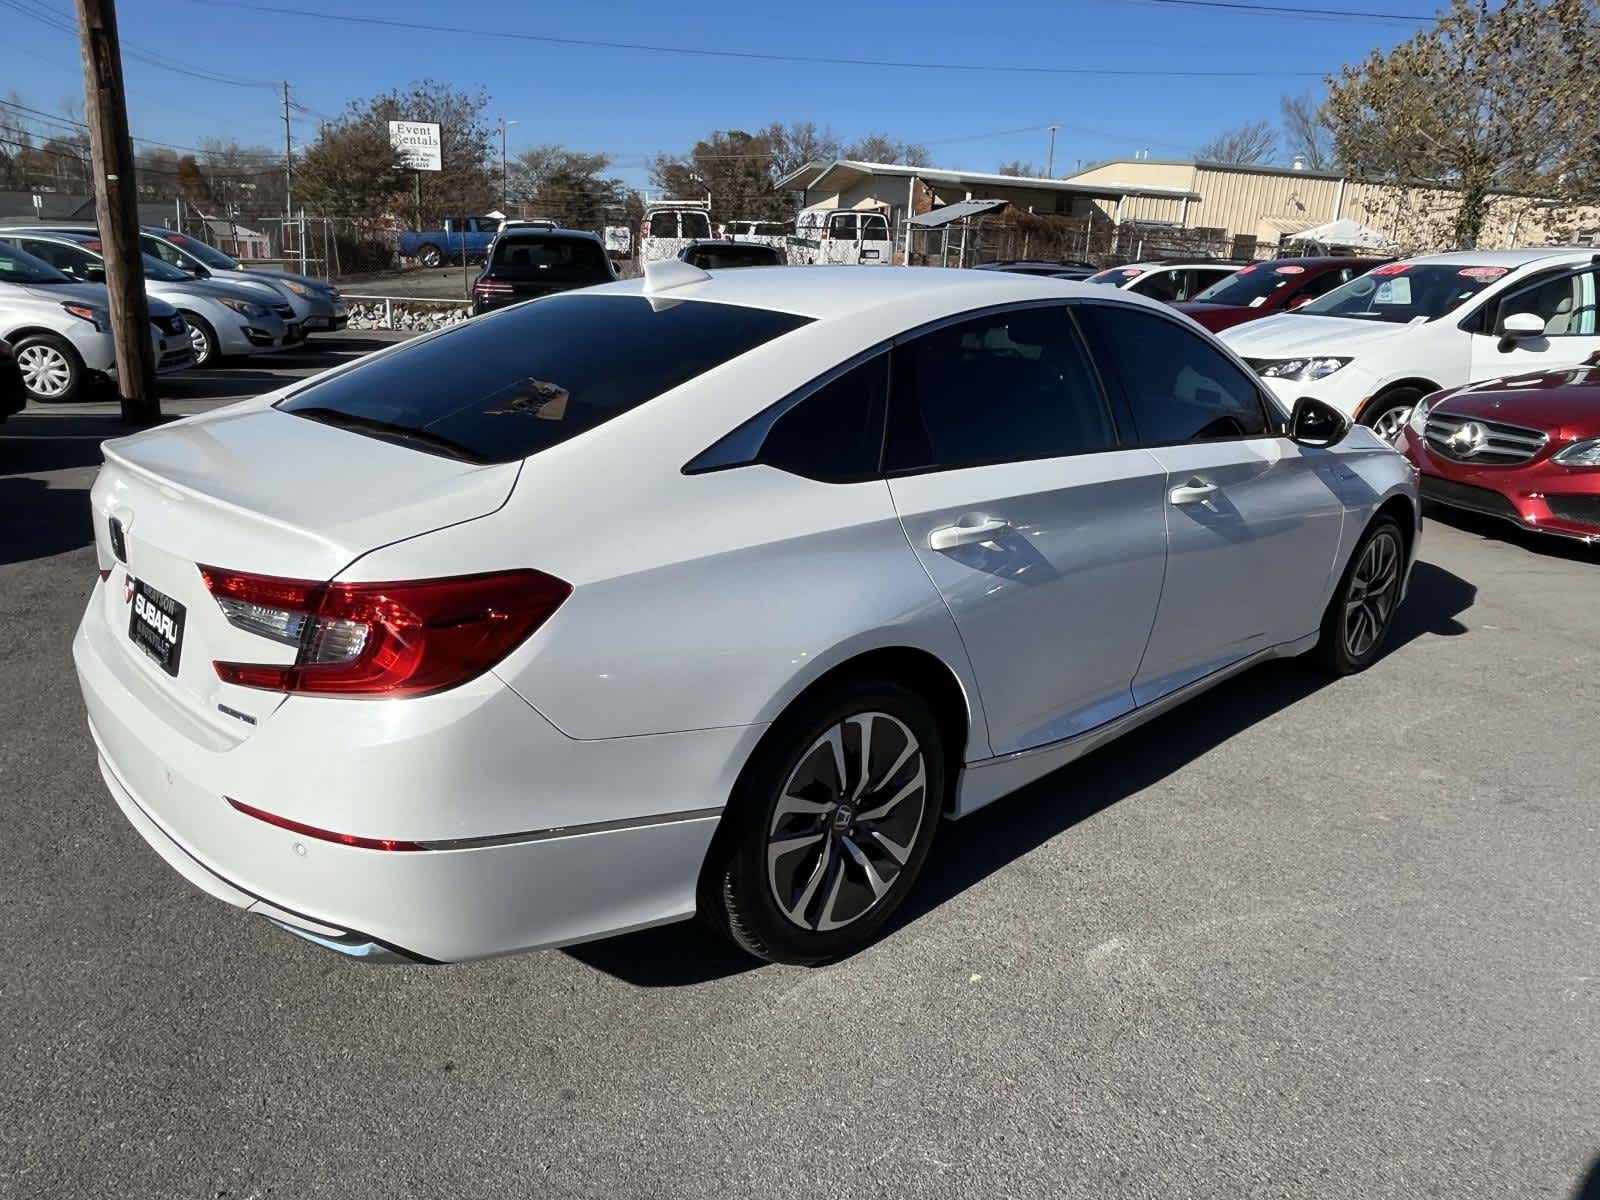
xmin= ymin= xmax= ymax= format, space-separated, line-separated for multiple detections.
xmin=1219 ymin=246 xmax=1600 ymax=440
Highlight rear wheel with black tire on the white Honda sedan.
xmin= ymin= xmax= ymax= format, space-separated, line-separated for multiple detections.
xmin=701 ymin=680 xmax=949 ymax=966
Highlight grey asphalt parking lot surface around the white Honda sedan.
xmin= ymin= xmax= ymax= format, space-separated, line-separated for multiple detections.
xmin=0 ymin=334 xmax=1600 ymax=1200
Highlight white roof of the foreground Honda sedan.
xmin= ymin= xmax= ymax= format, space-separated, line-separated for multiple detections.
xmin=590 ymin=266 xmax=1171 ymax=325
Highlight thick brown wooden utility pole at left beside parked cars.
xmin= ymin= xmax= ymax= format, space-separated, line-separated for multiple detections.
xmin=77 ymin=0 xmax=162 ymax=426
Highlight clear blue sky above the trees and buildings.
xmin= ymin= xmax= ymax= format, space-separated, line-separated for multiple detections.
xmin=0 ymin=0 xmax=1434 ymax=184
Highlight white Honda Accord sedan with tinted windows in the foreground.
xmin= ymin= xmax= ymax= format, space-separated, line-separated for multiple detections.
xmin=74 ymin=262 xmax=1419 ymax=963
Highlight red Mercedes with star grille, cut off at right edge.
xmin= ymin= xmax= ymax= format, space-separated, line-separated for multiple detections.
xmin=1398 ymin=362 xmax=1600 ymax=542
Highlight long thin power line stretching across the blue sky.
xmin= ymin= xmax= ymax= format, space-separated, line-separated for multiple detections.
xmin=184 ymin=0 xmax=1328 ymax=78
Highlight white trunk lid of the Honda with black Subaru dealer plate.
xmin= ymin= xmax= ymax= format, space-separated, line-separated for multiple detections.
xmin=91 ymin=406 xmax=520 ymax=738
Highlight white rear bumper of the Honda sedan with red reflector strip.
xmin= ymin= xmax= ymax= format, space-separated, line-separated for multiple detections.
xmin=74 ymin=603 xmax=760 ymax=962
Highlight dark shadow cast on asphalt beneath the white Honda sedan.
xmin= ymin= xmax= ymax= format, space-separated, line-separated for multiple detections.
xmin=566 ymin=562 xmax=1478 ymax=992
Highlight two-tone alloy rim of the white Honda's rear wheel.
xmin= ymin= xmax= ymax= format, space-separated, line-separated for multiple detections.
xmin=766 ymin=712 xmax=928 ymax=933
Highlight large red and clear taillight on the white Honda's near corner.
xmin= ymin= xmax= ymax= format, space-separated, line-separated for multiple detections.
xmin=200 ymin=566 xmax=573 ymax=698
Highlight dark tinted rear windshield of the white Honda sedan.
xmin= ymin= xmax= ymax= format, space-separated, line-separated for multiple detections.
xmin=278 ymin=294 xmax=811 ymax=462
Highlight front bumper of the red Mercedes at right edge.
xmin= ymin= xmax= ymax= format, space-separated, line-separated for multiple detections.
xmin=1400 ymin=429 xmax=1600 ymax=542
